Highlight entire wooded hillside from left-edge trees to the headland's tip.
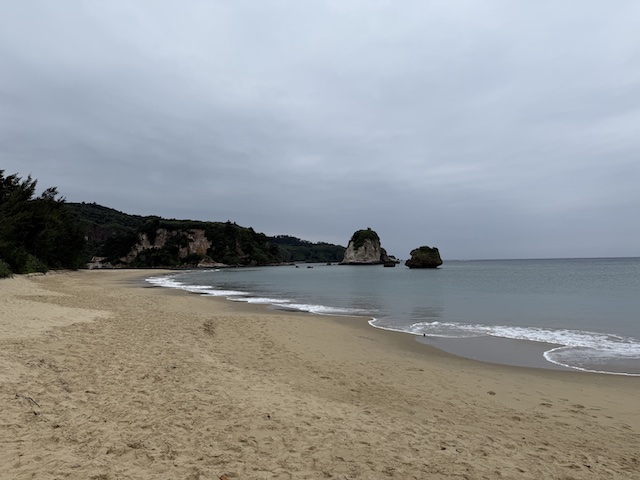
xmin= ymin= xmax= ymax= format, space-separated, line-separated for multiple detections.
xmin=0 ymin=170 xmax=345 ymax=277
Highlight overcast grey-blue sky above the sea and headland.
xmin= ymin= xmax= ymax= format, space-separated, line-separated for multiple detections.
xmin=0 ymin=0 xmax=640 ymax=260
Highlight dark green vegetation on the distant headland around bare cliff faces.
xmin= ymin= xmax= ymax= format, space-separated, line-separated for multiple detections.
xmin=69 ymin=203 xmax=344 ymax=267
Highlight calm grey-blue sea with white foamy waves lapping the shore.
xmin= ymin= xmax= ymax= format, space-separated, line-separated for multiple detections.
xmin=147 ymin=258 xmax=640 ymax=376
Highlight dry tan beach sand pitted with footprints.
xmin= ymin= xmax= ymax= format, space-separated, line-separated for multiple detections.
xmin=0 ymin=271 xmax=640 ymax=480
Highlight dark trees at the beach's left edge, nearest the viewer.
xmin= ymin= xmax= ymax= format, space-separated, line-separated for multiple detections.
xmin=0 ymin=170 xmax=84 ymax=277
